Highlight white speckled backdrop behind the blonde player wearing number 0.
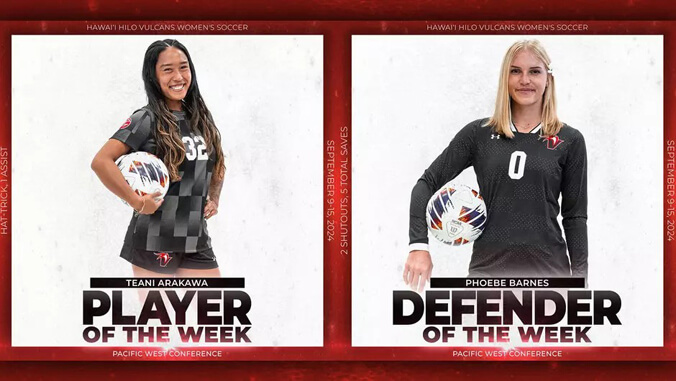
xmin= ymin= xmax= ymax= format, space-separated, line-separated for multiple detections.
xmin=352 ymin=35 xmax=665 ymax=347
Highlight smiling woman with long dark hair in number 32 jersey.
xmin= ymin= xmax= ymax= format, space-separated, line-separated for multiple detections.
xmin=92 ymin=40 xmax=225 ymax=277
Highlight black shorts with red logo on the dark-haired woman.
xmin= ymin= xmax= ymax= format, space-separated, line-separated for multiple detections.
xmin=120 ymin=245 xmax=218 ymax=274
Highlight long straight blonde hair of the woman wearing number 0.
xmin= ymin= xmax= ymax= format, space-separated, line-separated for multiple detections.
xmin=486 ymin=40 xmax=563 ymax=138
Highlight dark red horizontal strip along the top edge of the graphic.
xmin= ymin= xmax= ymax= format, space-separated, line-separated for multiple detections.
xmin=0 ymin=0 xmax=676 ymax=21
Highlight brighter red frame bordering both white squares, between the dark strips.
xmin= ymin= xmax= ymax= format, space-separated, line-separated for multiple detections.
xmin=0 ymin=20 xmax=676 ymax=361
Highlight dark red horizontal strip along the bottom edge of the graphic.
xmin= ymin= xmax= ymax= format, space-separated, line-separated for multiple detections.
xmin=0 ymin=361 xmax=676 ymax=381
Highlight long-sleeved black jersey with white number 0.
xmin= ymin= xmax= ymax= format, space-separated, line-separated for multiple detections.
xmin=409 ymin=119 xmax=587 ymax=277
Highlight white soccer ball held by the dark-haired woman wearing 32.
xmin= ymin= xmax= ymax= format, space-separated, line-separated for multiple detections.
xmin=115 ymin=151 xmax=170 ymax=200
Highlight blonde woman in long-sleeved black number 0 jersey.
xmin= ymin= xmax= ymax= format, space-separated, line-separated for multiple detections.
xmin=404 ymin=40 xmax=587 ymax=290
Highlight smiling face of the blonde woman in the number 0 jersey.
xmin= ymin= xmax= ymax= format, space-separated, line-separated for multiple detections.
xmin=508 ymin=50 xmax=547 ymax=108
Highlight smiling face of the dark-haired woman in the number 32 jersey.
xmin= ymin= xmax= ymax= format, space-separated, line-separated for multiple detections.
xmin=155 ymin=46 xmax=192 ymax=110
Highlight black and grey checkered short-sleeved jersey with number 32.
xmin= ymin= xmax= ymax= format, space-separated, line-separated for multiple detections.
xmin=112 ymin=109 xmax=214 ymax=253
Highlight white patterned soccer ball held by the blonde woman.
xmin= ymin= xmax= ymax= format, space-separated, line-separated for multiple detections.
xmin=426 ymin=182 xmax=487 ymax=246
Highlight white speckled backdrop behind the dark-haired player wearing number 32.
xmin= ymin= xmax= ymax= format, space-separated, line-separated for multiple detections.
xmin=11 ymin=35 xmax=323 ymax=347
